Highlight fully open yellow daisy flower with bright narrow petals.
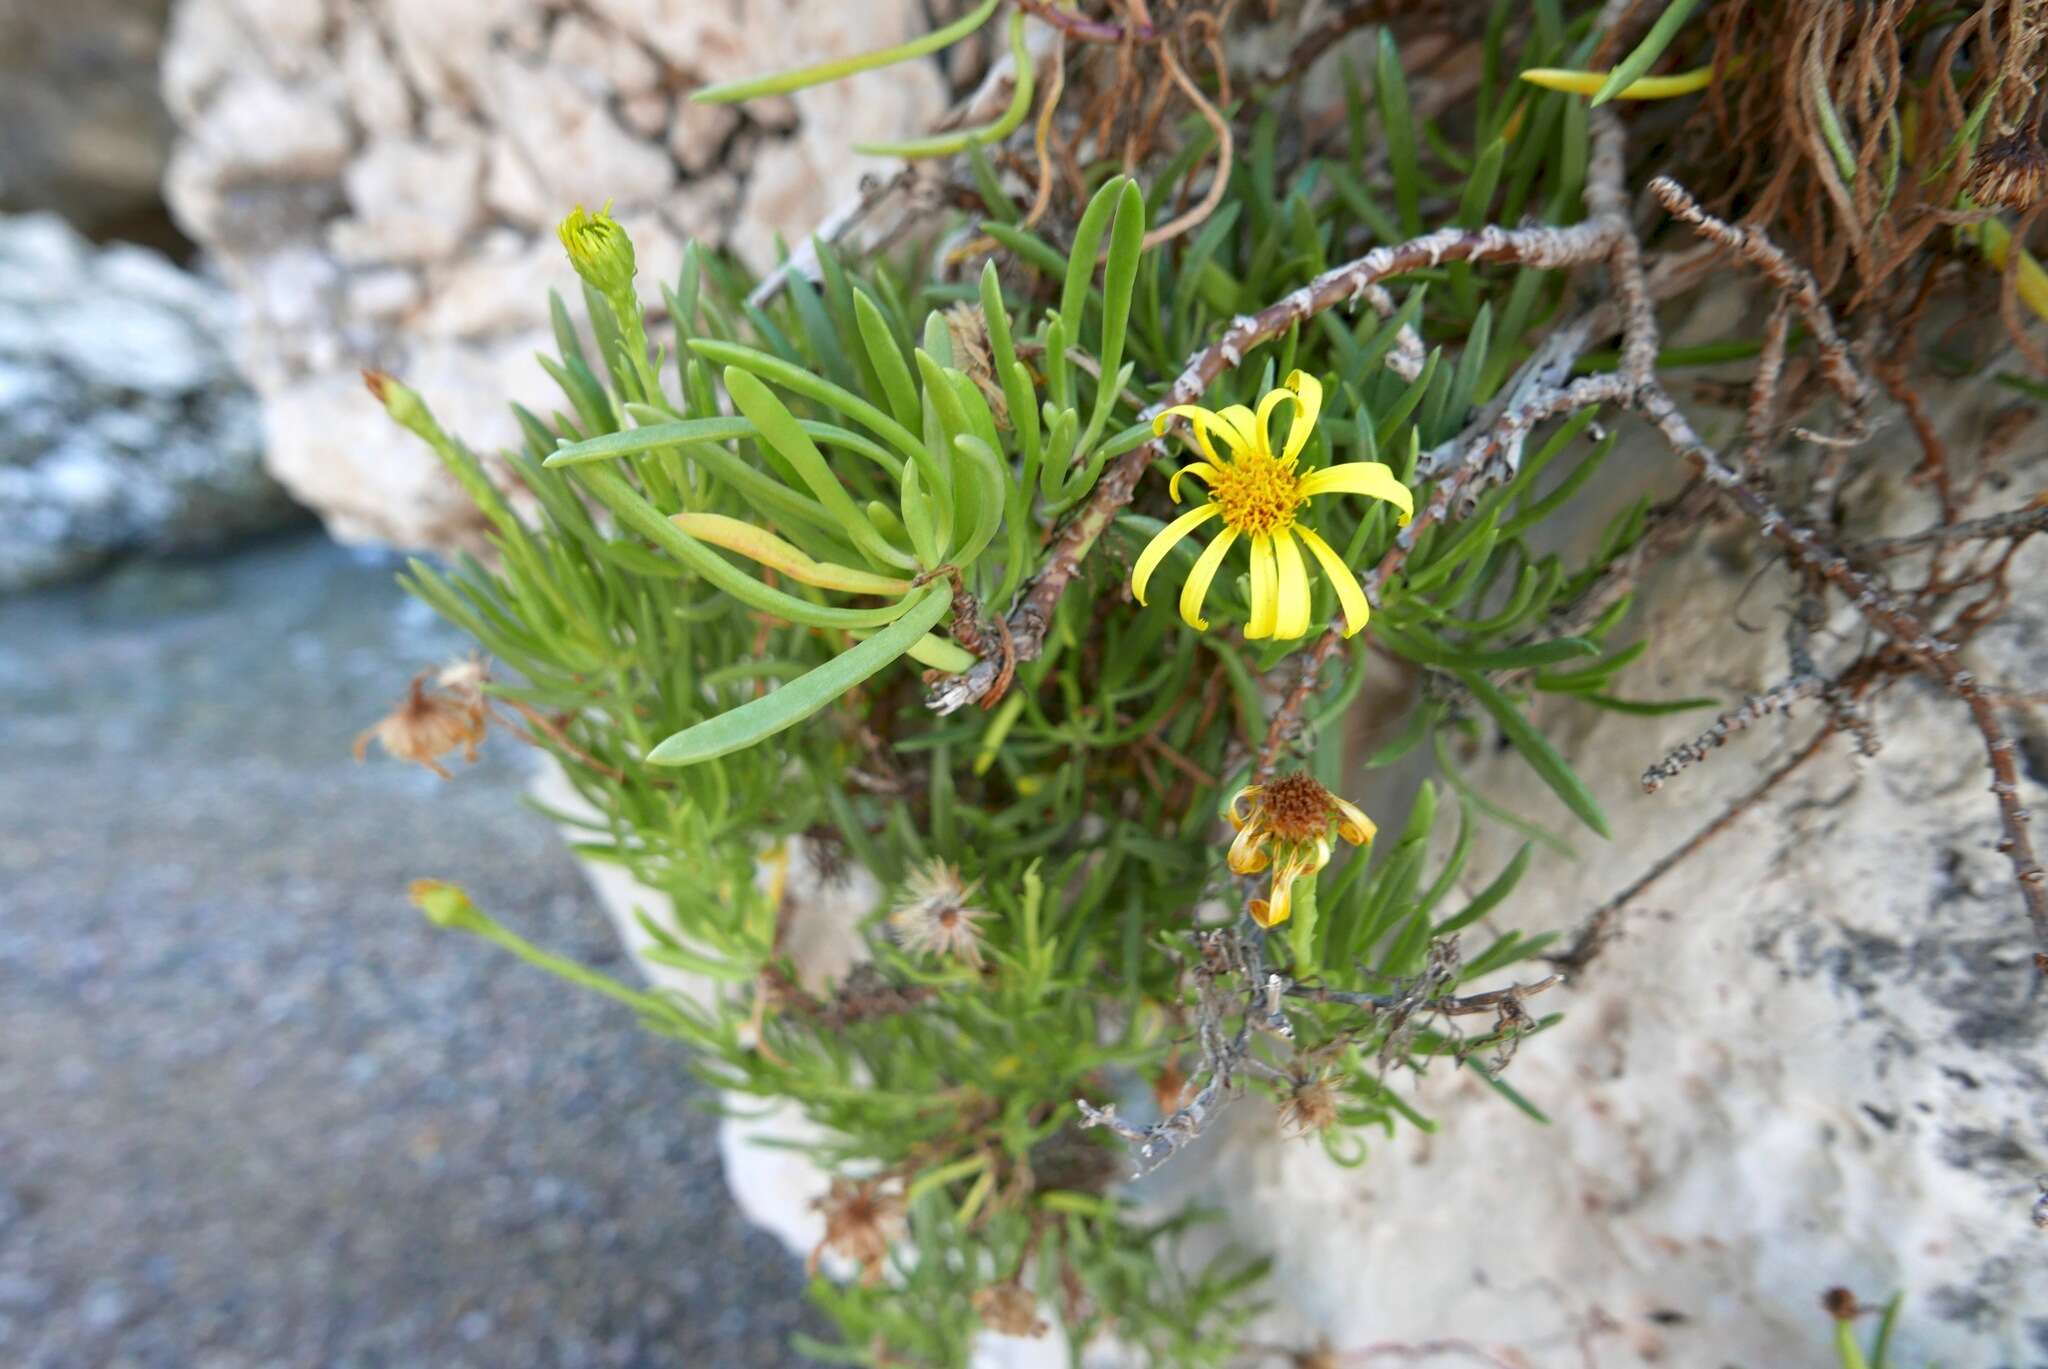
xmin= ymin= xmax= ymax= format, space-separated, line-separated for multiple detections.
xmin=1130 ymin=371 xmax=1415 ymax=639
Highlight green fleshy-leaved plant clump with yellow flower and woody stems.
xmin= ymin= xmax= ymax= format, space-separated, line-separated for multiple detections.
xmin=358 ymin=0 xmax=2048 ymax=1365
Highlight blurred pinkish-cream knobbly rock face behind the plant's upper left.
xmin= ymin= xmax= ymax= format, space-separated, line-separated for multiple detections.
xmin=164 ymin=0 xmax=948 ymax=547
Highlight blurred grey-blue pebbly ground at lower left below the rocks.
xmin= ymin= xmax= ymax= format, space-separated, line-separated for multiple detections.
xmin=0 ymin=537 xmax=817 ymax=1369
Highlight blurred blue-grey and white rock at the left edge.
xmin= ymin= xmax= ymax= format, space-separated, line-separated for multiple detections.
xmin=0 ymin=213 xmax=297 ymax=592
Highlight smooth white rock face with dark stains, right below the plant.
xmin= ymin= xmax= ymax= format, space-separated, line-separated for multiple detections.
xmin=557 ymin=367 xmax=2048 ymax=1369
